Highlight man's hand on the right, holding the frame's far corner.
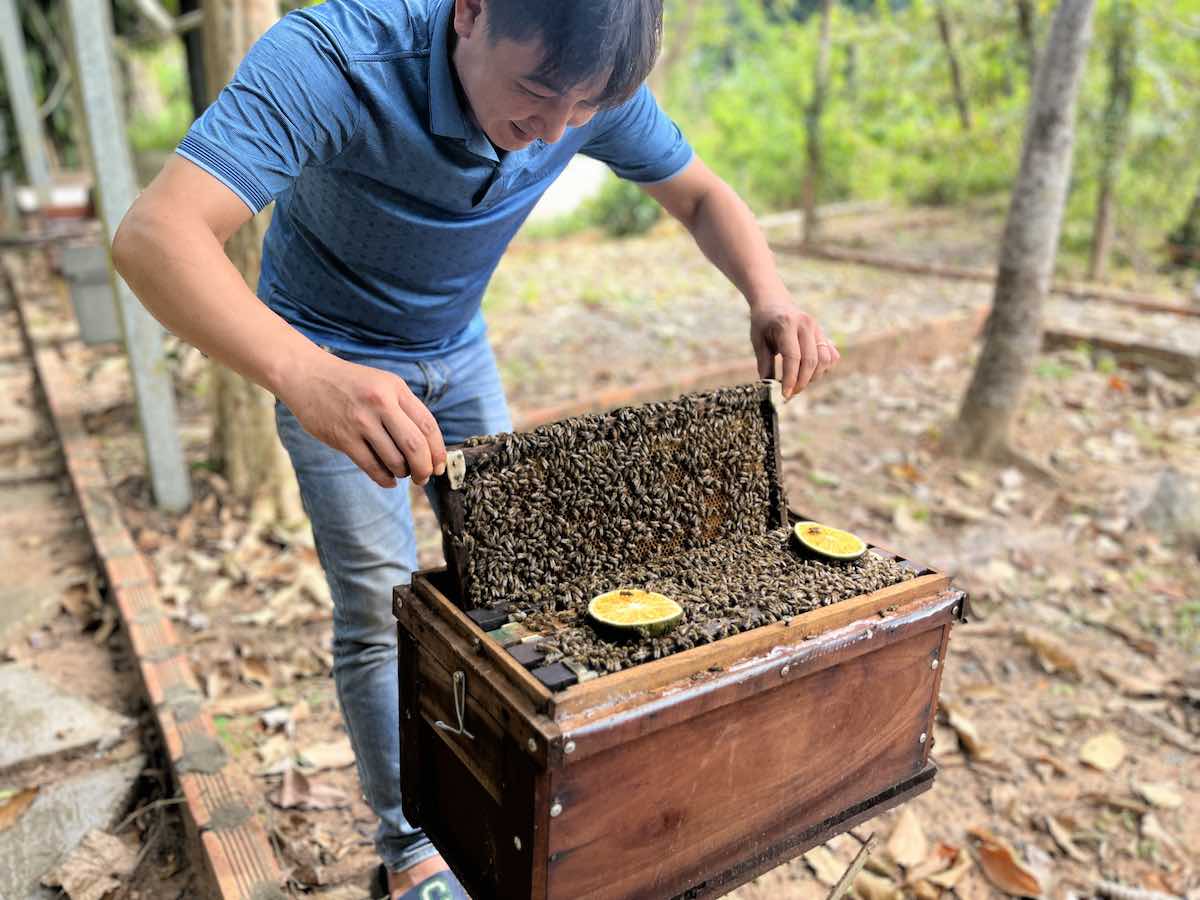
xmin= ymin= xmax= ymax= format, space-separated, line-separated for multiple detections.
xmin=750 ymin=298 xmax=841 ymax=400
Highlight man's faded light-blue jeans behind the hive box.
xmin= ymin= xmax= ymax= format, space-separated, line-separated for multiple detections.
xmin=276 ymin=336 xmax=512 ymax=871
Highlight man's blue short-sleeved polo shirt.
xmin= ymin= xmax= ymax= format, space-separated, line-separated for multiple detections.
xmin=178 ymin=0 xmax=691 ymax=359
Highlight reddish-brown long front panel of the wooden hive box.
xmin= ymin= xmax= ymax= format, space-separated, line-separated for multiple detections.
xmin=550 ymin=631 xmax=941 ymax=900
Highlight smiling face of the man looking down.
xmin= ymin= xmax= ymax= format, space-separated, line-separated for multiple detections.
xmin=454 ymin=0 xmax=607 ymax=150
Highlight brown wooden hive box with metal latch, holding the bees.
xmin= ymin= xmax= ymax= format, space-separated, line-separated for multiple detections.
xmin=394 ymin=384 xmax=966 ymax=900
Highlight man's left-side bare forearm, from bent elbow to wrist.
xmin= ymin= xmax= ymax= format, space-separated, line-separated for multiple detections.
xmin=113 ymin=204 xmax=318 ymax=403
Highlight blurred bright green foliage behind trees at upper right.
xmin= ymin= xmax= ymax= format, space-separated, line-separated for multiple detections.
xmin=662 ymin=0 xmax=1200 ymax=271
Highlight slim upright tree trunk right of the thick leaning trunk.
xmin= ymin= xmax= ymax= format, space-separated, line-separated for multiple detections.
xmin=1087 ymin=0 xmax=1138 ymax=281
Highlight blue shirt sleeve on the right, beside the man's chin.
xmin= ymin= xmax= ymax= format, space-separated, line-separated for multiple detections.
xmin=580 ymin=84 xmax=692 ymax=185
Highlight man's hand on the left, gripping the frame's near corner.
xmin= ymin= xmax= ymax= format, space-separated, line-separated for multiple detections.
xmin=278 ymin=352 xmax=446 ymax=487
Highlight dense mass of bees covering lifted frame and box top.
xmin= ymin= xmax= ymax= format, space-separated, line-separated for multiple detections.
xmin=456 ymin=384 xmax=913 ymax=672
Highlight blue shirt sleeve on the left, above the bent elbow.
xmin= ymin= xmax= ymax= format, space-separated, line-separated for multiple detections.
xmin=175 ymin=11 xmax=360 ymax=212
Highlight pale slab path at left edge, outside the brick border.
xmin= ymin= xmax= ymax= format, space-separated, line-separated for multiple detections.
xmin=0 ymin=271 xmax=145 ymax=900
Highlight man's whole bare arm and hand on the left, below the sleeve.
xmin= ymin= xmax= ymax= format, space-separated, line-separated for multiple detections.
xmin=113 ymin=156 xmax=446 ymax=487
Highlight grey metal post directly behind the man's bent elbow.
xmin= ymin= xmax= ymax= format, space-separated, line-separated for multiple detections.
xmin=67 ymin=0 xmax=191 ymax=511
